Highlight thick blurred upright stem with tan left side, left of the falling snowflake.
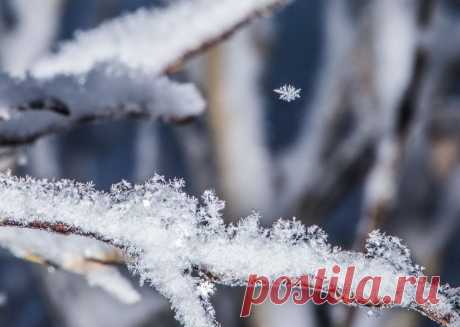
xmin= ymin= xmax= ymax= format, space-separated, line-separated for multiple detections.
xmin=207 ymin=26 xmax=273 ymax=217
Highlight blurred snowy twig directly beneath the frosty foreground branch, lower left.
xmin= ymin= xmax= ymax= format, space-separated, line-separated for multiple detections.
xmin=0 ymin=224 xmax=140 ymax=304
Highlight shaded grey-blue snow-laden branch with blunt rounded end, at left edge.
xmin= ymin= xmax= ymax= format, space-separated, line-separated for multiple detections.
xmin=0 ymin=64 xmax=205 ymax=145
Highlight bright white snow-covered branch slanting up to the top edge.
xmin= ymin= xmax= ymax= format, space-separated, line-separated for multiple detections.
xmin=32 ymin=0 xmax=288 ymax=77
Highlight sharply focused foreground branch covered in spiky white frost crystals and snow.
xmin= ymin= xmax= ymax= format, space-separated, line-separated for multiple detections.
xmin=0 ymin=175 xmax=460 ymax=327
